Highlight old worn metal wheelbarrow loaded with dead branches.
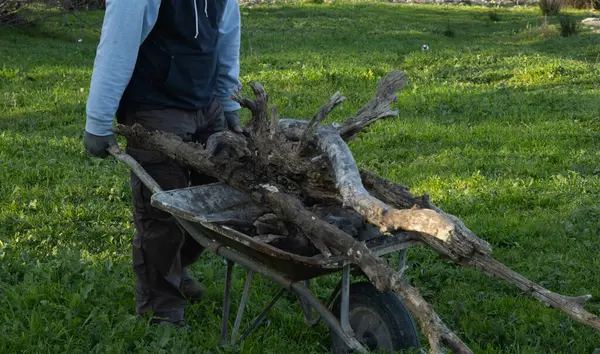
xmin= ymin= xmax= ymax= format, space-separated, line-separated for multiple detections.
xmin=108 ymin=146 xmax=420 ymax=354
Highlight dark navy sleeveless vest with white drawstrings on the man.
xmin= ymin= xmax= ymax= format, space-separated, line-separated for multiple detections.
xmin=119 ymin=0 xmax=225 ymax=112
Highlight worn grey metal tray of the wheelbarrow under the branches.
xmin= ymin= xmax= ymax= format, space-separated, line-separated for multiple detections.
xmin=151 ymin=183 xmax=419 ymax=281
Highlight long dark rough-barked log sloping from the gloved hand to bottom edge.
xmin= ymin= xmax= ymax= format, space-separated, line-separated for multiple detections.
xmin=116 ymin=85 xmax=471 ymax=353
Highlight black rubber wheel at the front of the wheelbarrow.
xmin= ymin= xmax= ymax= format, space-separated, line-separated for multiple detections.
xmin=330 ymin=282 xmax=421 ymax=354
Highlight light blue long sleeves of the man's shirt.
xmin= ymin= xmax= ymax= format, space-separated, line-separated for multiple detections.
xmin=85 ymin=0 xmax=240 ymax=136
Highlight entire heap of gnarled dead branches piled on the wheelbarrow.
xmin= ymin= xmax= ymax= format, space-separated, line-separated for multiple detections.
xmin=117 ymin=72 xmax=600 ymax=353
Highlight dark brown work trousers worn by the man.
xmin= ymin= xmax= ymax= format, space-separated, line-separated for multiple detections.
xmin=119 ymin=99 xmax=227 ymax=322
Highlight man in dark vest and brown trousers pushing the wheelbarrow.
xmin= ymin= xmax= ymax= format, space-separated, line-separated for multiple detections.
xmin=83 ymin=0 xmax=242 ymax=325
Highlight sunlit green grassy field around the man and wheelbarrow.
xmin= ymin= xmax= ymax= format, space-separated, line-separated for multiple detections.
xmin=0 ymin=3 xmax=600 ymax=353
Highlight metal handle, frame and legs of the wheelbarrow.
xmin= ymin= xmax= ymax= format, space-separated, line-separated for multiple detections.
xmin=113 ymin=146 xmax=420 ymax=352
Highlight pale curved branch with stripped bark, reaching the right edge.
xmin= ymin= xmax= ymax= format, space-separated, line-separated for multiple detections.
xmin=292 ymin=75 xmax=600 ymax=330
